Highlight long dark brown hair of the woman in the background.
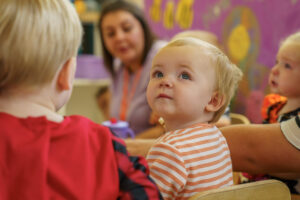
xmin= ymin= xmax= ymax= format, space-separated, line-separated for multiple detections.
xmin=98 ymin=0 xmax=156 ymax=78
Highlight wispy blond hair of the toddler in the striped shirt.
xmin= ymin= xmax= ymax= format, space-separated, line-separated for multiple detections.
xmin=164 ymin=37 xmax=243 ymax=122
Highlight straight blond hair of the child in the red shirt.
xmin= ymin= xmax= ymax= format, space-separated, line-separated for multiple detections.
xmin=0 ymin=0 xmax=82 ymax=94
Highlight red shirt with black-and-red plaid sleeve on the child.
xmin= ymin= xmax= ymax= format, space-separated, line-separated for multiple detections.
xmin=0 ymin=113 xmax=160 ymax=200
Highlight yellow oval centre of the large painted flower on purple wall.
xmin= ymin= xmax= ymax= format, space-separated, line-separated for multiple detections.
xmin=228 ymin=24 xmax=250 ymax=62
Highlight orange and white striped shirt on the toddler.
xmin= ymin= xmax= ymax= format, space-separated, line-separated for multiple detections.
xmin=147 ymin=124 xmax=233 ymax=200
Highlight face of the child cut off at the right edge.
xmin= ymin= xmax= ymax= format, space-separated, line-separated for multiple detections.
xmin=269 ymin=43 xmax=300 ymax=97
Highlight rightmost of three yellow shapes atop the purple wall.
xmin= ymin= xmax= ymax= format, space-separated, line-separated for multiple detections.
xmin=175 ymin=0 xmax=194 ymax=29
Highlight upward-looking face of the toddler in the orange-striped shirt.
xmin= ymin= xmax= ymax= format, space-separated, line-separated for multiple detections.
xmin=147 ymin=45 xmax=216 ymax=123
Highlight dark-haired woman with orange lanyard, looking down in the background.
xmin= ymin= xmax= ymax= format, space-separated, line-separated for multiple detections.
xmin=98 ymin=1 xmax=166 ymax=137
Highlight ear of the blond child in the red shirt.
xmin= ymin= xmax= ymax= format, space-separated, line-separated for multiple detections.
xmin=57 ymin=58 xmax=76 ymax=90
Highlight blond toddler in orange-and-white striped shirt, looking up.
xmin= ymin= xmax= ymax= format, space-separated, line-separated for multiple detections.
xmin=147 ymin=37 xmax=242 ymax=199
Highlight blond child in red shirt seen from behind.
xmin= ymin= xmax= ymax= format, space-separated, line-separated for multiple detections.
xmin=0 ymin=0 xmax=160 ymax=200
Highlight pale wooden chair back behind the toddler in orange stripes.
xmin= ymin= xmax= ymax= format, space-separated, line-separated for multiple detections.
xmin=189 ymin=180 xmax=291 ymax=200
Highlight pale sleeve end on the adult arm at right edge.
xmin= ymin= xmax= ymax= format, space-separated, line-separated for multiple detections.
xmin=280 ymin=115 xmax=300 ymax=150
